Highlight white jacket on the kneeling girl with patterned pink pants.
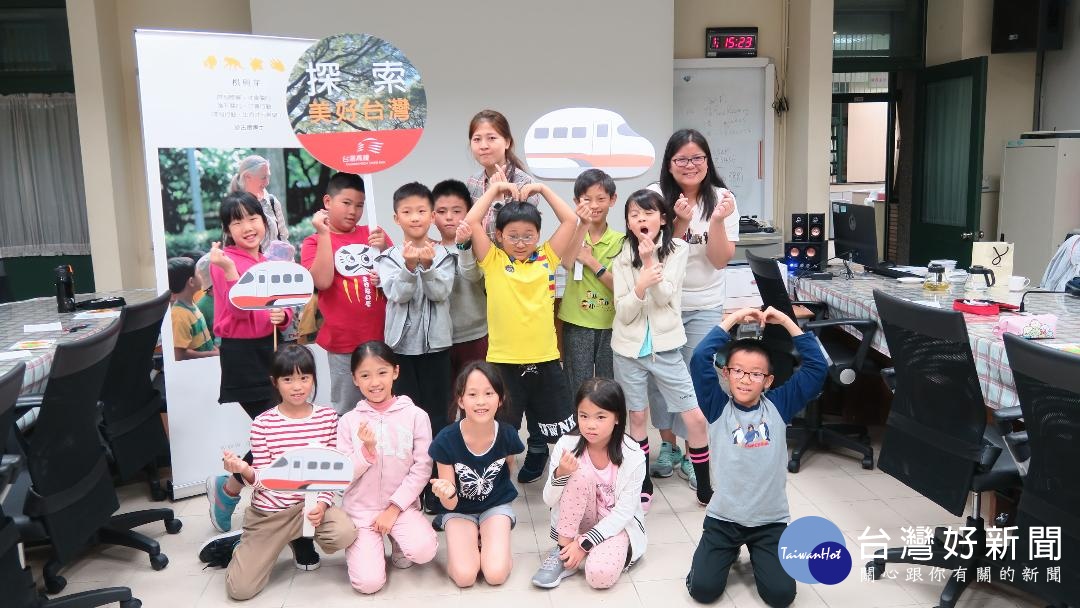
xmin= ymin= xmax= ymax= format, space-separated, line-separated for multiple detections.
xmin=543 ymin=434 xmax=648 ymax=565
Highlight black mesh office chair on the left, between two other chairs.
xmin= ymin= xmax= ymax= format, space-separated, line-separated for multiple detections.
xmin=4 ymin=314 xmax=180 ymax=593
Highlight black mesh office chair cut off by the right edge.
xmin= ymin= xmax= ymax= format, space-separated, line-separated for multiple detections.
xmin=1004 ymin=334 xmax=1080 ymax=606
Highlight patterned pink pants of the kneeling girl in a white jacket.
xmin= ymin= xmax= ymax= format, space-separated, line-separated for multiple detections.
xmin=557 ymin=469 xmax=630 ymax=589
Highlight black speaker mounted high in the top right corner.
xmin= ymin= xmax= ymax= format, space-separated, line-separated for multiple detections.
xmin=990 ymin=0 xmax=1065 ymax=53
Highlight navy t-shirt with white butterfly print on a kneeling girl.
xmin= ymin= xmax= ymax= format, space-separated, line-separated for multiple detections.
xmin=428 ymin=421 xmax=525 ymax=514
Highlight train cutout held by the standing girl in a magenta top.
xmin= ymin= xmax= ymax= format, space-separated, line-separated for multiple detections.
xmin=229 ymin=261 xmax=315 ymax=310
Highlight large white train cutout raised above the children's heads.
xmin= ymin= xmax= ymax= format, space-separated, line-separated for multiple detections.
xmin=525 ymin=108 xmax=657 ymax=179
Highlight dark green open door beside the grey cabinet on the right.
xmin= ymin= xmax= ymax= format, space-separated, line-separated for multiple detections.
xmin=909 ymin=57 xmax=986 ymax=268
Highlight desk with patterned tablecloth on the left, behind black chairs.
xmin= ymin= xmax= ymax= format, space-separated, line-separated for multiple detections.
xmin=0 ymin=289 xmax=157 ymax=394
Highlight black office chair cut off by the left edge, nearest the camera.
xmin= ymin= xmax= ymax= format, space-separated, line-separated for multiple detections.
xmin=0 ymin=363 xmax=143 ymax=608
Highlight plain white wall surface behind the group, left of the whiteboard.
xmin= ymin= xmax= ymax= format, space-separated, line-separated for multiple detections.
xmin=251 ymin=0 xmax=674 ymax=237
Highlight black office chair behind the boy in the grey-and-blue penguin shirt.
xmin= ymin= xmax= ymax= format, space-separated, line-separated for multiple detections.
xmin=746 ymin=252 xmax=878 ymax=473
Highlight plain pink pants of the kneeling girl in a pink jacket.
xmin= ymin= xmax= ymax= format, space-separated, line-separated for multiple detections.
xmin=345 ymin=506 xmax=438 ymax=594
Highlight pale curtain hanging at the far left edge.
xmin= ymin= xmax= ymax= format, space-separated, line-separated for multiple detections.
xmin=0 ymin=93 xmax=90 ymax=258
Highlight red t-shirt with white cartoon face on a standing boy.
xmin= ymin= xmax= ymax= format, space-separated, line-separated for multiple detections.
xmin=300 ymin=226 xmax=393 ymax=353
